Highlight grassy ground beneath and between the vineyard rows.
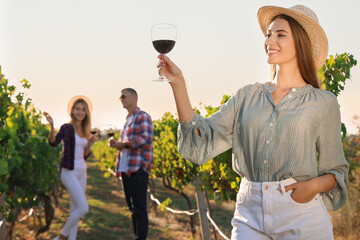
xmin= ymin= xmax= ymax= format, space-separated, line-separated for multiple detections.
xmin=8 ymin=160 xmax=360 ymax=240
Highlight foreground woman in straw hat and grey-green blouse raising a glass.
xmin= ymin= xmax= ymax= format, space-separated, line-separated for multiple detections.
xmin=159 ymin=5 xmax=348 ymax=240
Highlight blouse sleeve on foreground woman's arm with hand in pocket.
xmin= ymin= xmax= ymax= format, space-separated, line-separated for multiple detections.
xmin=317 ymin=95 xmax=349 ymax=211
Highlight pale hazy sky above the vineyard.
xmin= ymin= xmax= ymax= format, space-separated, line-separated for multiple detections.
xmin=0 ymin=0 xmax=360 ymax=133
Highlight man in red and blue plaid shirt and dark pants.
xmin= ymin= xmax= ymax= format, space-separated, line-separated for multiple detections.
xmin=109 ymin=88 xmax=153 ymax=240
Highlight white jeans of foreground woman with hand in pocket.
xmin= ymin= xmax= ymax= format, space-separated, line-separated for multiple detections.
xmin=231 ymin=178 xmax=334 ymax=240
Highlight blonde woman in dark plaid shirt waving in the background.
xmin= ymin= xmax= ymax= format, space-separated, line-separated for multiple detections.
xmin=45 ymin=96 xmax=96 ymax=240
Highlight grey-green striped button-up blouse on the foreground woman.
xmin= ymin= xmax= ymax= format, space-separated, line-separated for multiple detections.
xmin=178 ymin=83 xmax=349 ymax=210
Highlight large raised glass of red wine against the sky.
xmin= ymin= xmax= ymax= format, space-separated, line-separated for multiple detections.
xmin=151 ymin=23 xmax=177 ymax=82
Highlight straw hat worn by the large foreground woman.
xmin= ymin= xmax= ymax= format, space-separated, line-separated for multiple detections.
xmin=257 ymin=5 xmax=329 ymax=70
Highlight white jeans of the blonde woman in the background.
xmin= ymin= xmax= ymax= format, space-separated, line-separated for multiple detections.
xmin=61 ymin=168 xmax=89 ymax=240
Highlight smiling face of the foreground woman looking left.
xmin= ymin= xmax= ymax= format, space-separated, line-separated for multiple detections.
xmin=265 ymin=18 xmax=297 ymax=66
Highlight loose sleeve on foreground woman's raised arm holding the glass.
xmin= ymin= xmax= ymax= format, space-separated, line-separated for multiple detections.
xmin=178 ymin=94 xmax=239 ymax=165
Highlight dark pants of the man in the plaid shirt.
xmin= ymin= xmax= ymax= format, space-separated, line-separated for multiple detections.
xmin=121 ymin=168 xmax=149 ymax=240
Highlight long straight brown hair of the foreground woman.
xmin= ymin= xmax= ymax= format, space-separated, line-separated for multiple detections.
xmin=265 ymin=14 xmax=320 ymax=88
